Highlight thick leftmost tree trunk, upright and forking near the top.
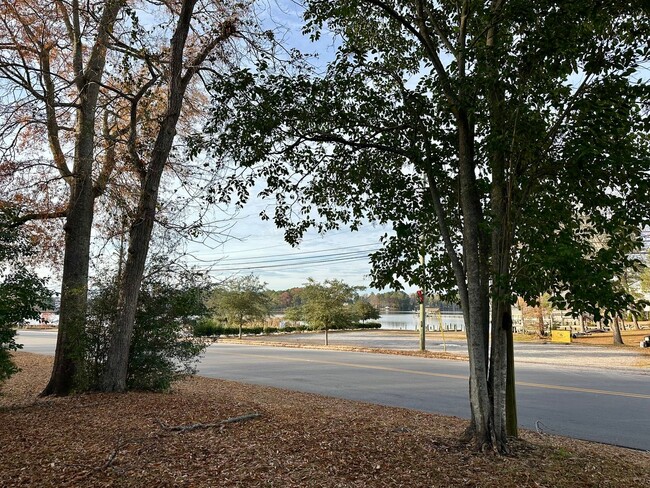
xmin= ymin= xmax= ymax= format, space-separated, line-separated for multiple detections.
xmin=42 ymin=0 xmax=124 ymax=395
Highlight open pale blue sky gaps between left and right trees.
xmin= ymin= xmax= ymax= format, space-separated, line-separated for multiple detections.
xmin=173 ymin=0 xmax=400 ymax=290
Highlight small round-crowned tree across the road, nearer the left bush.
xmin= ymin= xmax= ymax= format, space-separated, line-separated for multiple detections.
xmin=208 ymin=275 xmax=271 ymax=339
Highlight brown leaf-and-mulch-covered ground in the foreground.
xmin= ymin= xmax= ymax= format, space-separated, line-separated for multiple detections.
xmin=0 ymin=353 xmax=650 ymax=488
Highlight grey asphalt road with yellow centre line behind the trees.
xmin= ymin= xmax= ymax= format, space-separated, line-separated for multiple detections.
xmin=19 ymin=331 xmax=650 ymax=450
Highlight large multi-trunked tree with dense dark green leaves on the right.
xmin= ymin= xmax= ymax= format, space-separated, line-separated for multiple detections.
xmin=196 ymin=0 xmax=650 ymax=451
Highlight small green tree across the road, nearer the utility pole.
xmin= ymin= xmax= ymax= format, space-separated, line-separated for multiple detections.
xmin=301 ymin=278 xmax=360 ymax=345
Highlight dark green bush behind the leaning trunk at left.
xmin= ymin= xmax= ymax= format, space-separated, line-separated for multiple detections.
xmin=85 ymin=275 xmax=208 ymax=391
